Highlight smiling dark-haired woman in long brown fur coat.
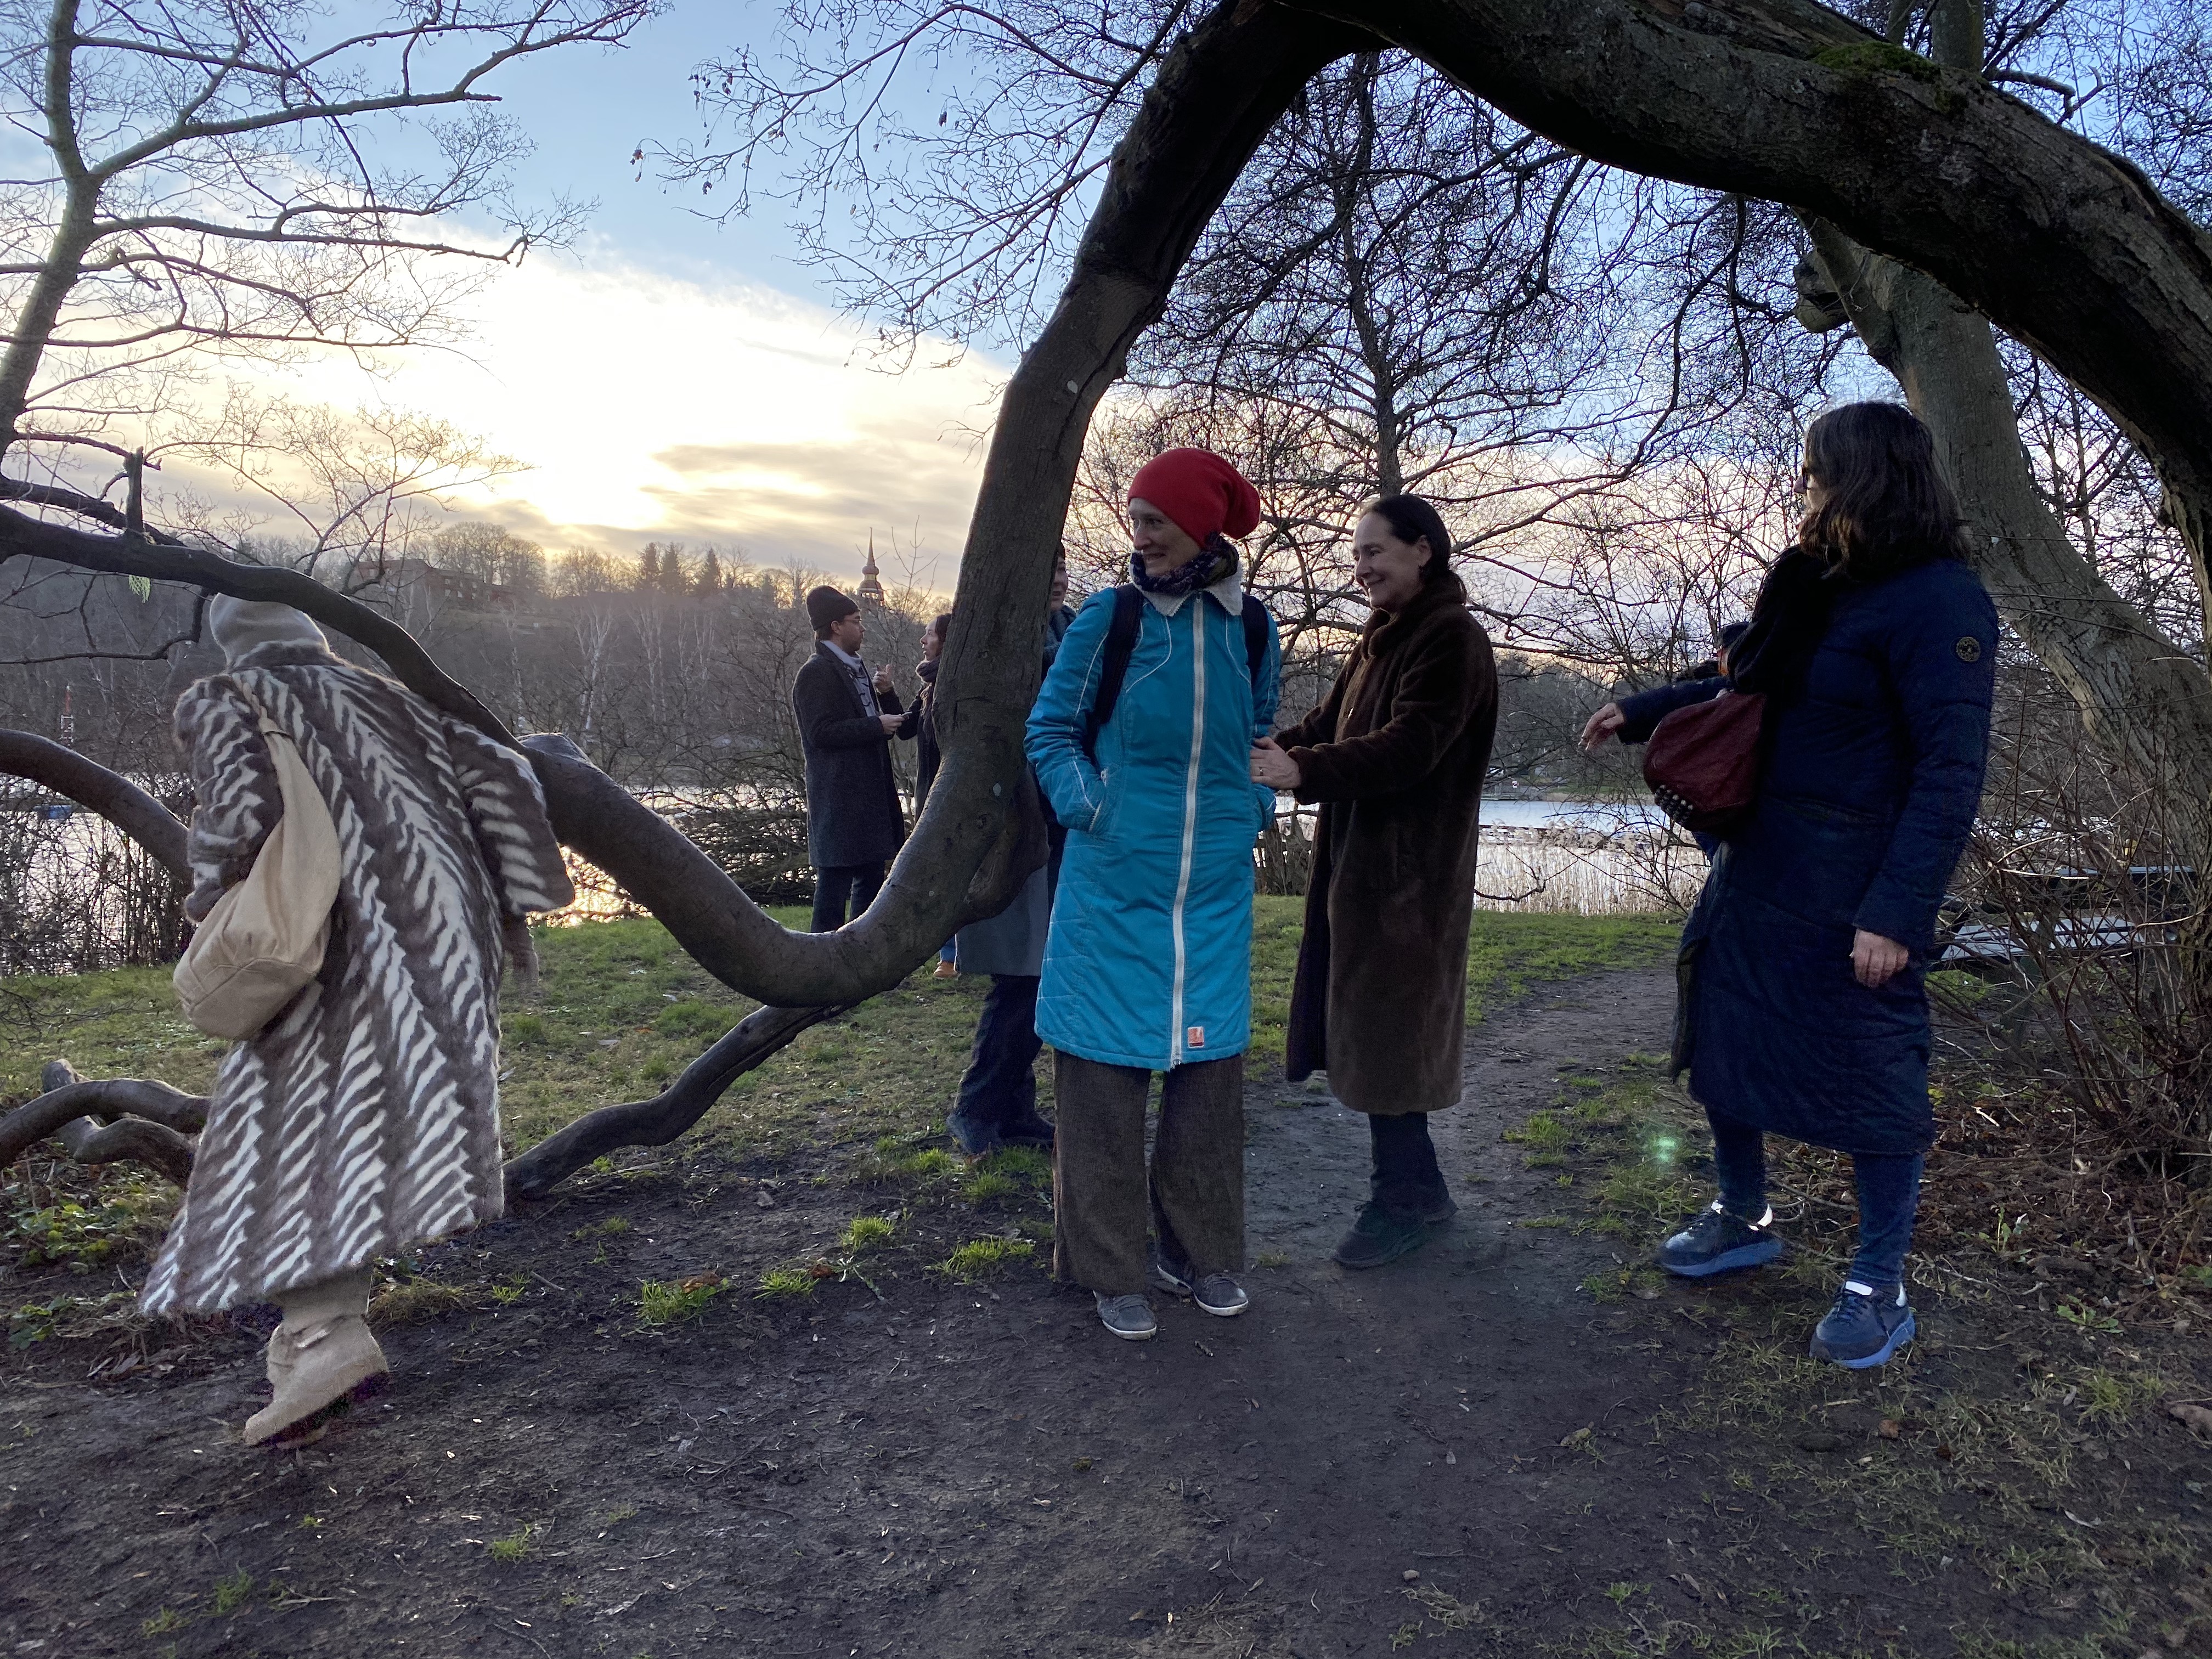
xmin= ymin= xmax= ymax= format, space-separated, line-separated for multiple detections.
xmin=1252 ymin=495 xmax=1498 ymax=1267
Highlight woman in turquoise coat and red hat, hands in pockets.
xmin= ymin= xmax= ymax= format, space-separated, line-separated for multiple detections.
xmin=1029 ymin=449 xmax=1281 ymax=1340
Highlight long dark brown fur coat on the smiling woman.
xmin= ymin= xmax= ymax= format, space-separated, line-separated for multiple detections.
xmin=1276 ymin=582 xmax=1498 ymax=1117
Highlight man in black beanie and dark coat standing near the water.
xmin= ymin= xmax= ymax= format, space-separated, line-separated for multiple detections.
xmin=792 ymin=589 xmax=907 ymax=934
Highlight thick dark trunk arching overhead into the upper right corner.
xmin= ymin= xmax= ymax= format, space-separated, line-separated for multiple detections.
xmin=1294 ymin=0 xmax=2212 ymax=566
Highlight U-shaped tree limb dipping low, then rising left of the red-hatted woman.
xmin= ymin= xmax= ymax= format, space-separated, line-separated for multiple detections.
xmin=0 ymin=0 xmax=1376 ymax=1007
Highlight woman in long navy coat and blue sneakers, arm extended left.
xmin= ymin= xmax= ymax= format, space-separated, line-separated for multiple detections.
xmin=1584 ymin=403 xmax=1997 ymax=1369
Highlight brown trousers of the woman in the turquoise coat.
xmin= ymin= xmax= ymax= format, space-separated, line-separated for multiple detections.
xmin=1053 ymin=1053 xmax=1243 ymax=1296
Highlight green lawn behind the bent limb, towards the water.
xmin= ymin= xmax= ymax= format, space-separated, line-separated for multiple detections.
xmin=0 ymin=898 xmax=1674 ymax=1291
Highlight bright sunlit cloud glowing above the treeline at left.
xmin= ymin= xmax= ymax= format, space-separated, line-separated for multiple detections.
xmin=256 ymin=246 xmax=1005 ymax=586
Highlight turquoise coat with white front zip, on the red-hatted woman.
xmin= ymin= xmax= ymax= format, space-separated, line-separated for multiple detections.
xmin=1029 ymin=577 xmax=1283 ymax=1070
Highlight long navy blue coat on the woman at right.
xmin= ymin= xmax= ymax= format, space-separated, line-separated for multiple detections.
xmin=1674 ymin=560 xmax=1997 ymax=1153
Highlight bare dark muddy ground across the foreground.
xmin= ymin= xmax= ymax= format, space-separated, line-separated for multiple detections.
xmin=0 ymin=971 xmax=2212 ymax=1659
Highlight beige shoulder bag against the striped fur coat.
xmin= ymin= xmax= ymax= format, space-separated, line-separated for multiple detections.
xmin=177 ymin=681 xmax=338 ymax=1037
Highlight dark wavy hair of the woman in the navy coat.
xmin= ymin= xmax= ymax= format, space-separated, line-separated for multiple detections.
xmin=1798 ymin=403 xmax=1966 ymax=582
